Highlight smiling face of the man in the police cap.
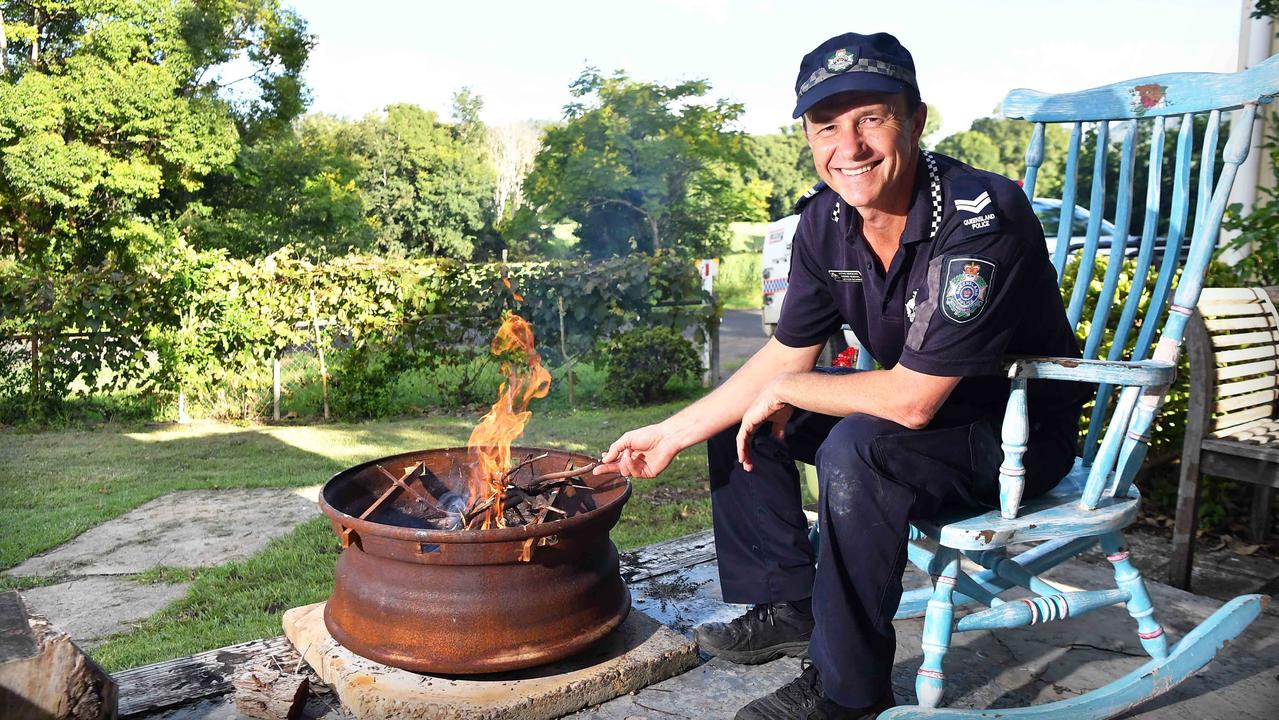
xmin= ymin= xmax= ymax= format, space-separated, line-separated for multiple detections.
xmin=804 ymin=92 xmax=927 ymax=216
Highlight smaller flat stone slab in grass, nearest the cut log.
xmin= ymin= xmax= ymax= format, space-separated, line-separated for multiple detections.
xmin=22 ymin=575 xmax=191 ymax=650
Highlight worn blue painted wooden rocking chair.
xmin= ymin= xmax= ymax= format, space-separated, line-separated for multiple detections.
xmin=863 ymin=56 xmax=1279 ymax=720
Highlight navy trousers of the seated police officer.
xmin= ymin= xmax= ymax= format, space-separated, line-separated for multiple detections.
xmin=707 ymin=411 xmax=1074 ymax=707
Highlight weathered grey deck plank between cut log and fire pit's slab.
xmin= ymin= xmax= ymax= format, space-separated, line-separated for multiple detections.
xmin=115 ymin=636 xmax=293 ymax=717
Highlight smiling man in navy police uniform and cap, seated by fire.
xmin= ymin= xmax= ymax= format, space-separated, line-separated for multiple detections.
xmin=597 ymin=33 xmax=1082 ymax=719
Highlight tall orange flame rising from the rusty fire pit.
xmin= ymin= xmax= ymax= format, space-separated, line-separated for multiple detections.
xmin=467 ymin=313 xmax=551 ymax=528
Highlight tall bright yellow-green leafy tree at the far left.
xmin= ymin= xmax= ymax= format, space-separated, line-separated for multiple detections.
xmin=0 ymin=0 xmax=311 ymax=407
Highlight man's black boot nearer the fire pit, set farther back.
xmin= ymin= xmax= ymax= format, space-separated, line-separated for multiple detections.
xmin=693 ymin=602 xmax=812 ymax=665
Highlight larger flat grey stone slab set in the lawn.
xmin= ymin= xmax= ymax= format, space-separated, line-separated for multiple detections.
xmin=5 ymin=489 xmax=320 ymax=577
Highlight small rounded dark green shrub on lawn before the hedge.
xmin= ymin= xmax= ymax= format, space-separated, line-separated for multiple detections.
xmin=605 ymin=327 xmax=702 ymax=404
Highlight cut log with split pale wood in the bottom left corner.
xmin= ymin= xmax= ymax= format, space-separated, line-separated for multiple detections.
xmin=0 ymin=591 xmax=118 ymax=720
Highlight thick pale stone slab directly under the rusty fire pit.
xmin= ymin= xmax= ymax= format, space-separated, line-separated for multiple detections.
xmin=284 ymin=602 xmax=698 ymax=720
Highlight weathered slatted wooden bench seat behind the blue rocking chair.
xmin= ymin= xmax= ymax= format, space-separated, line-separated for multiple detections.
xmin=1168 ymin=288 xmax=1279 ymax=590
